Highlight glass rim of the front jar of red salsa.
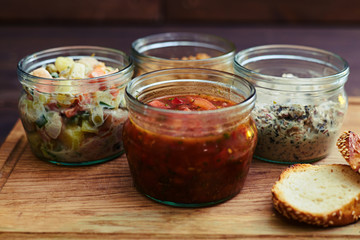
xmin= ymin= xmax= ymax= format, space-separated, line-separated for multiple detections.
xmin=125 ymin=68 xmax=256 ymax=116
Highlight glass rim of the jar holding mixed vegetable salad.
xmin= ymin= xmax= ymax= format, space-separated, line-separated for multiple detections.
xmin=17 ymin=45 xmax=133 ymax=82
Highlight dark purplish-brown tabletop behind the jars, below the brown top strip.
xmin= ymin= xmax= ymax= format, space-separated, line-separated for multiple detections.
xmin=0 ymin=24 xmax=360 ymax=144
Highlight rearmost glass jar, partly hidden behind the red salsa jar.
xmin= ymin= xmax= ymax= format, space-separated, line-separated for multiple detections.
xmin=131 ymin=32 xmax=235 ymax=76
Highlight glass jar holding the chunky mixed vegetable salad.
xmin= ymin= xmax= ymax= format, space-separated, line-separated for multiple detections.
xmin=17 ymin=46 xmax=134 ymax=165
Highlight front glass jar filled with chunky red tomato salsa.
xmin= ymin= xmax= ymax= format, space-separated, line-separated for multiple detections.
xmin=123 ymin=68 xmax=257 ymax=207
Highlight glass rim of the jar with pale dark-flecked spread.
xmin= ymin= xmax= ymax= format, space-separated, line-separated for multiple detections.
xmin=234 ymin=44 xmax=349 ymax=85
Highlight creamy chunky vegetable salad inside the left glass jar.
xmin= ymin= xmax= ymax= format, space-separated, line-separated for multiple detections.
xmin=19 ymin=56 xmax=127 ymax=165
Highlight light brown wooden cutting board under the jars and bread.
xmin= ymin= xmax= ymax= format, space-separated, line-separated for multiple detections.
xmin=0 ymin=98 xmax=360 ymax=239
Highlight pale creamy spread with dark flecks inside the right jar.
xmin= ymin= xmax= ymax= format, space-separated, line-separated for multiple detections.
xmin=253 ymin=102 xmax=344 ymax=163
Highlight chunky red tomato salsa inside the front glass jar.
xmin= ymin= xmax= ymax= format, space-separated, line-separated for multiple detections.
xmin=123 ymin=95 xmax=257 ymax=206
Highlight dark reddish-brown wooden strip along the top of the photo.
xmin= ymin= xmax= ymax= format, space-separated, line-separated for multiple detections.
xmin=0 ymin=0 xmax=360 ymax=25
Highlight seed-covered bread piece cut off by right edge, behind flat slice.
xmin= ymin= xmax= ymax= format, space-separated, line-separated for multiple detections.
xmin=336 ymin=131 xmax=360 ymax=173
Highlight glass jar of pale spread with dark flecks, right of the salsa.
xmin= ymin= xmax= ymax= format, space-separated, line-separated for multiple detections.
xmin=234 ymin=45 xmax=349 ymax=164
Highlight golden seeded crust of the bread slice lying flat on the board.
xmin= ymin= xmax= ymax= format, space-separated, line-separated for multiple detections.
xmin=272 ymin=164 xmax=360 ymax=227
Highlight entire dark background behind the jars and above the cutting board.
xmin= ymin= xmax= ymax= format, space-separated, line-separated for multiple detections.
xmin=0 ymin=0 xmax=360 ymax=144
